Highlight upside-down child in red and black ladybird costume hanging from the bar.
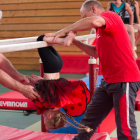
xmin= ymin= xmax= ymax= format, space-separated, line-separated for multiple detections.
xmin=32 ymin=32 xmax=92 ymax=132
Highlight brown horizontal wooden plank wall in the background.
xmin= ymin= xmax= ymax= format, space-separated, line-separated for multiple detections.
xmin=0 ymin=0 xmax=140 ymax=70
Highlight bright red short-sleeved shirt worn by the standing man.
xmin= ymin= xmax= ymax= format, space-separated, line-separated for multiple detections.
xmin=96 ymin=11 xmax=140 ymax=83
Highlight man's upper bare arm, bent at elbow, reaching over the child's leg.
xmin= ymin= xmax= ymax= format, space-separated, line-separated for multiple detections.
xmin=45 ymin=16 xmax=106 ymax=42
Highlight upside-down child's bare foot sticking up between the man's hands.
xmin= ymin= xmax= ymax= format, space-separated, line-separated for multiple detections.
xmin=64 ymin=31 xmax=77 ymax=47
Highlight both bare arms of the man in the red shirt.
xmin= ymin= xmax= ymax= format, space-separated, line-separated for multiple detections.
xmin=45 ymin=16 xmax=106 ymax=57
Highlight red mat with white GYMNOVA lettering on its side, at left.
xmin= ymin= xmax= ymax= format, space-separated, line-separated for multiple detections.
xmin=0 ymin=91 xmax=36 ymax=110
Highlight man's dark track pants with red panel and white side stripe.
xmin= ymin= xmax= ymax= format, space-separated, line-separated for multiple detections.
xmin=73 ymin=79 xmax=140 ymax=140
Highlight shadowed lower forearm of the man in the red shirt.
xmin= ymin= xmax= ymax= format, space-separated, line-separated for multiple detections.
xmin=73 ymin=39 xmax=98 ymax=58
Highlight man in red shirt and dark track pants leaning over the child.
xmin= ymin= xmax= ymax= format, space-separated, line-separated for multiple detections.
xmin=46 ymin=0 xmax=140 ymax=140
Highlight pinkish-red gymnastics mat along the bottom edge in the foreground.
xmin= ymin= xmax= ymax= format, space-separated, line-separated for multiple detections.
xmin=0 ymin=125 xmax=117 ymax=140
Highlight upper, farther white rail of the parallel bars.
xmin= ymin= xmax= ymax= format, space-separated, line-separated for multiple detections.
xmin=0 ymin=34 xmax=96 ymax=45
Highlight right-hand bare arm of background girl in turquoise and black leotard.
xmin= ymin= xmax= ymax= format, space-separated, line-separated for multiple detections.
xmin=125 ymin=3 xmax=134 ymax=26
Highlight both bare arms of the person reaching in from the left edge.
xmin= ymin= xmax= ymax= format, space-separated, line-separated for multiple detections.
xmin=0 ymin=54 xmax=41 ymax=100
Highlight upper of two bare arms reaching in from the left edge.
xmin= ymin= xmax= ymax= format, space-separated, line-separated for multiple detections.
xmin=0 ymin=53 xmax=30 ymax=84
